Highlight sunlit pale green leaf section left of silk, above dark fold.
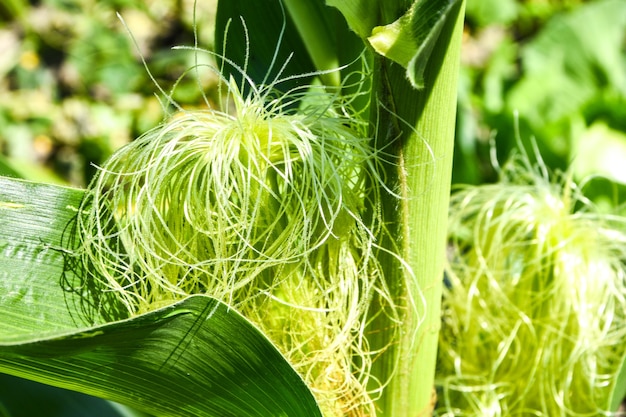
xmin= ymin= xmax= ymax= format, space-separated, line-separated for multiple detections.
xmin=0 ymin=178 xmax=98 ymax=343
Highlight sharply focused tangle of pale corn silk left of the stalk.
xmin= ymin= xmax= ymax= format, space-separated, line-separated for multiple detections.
xmin=64 ymin=8 xmax=404 ymax=416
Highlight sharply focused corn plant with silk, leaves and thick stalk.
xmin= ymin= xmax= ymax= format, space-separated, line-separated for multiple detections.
xmin=0 ymin=0 xmax=464 ymax=417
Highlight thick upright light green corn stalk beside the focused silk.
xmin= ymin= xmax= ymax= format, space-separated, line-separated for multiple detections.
xmin=369 ymin=3 xmax=464 ymax=417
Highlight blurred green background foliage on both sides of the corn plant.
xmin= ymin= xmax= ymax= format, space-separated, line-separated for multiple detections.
xmin=0 ymin=0 xmax=626 ymax=195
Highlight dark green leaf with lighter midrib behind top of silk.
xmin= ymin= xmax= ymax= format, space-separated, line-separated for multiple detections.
xmin=215 ymin=0 xmax=364 ymax=92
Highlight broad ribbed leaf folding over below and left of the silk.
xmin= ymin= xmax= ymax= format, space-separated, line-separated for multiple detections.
xmin=0 ymin=178 xmax=321 ymax=417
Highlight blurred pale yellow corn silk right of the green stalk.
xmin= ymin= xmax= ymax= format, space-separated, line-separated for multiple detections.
xmin=437 ymin=141 xmax=626 ymax=417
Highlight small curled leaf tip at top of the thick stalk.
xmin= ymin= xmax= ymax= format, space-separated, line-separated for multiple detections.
xmin=368 ymin=0 xmax=460 ymax=88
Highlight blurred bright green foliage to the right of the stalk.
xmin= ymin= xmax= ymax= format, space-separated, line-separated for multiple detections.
xmin=453 ymin=0 xmax=626 ymax=199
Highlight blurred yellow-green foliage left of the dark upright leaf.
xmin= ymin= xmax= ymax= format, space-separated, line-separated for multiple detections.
xmin=0 ymin=0 xmax=215 ymax=186
